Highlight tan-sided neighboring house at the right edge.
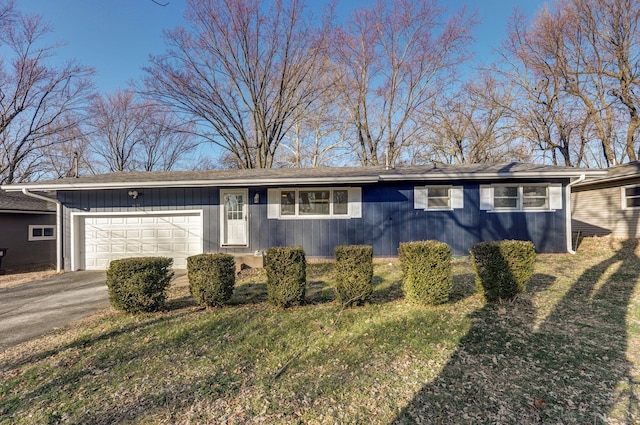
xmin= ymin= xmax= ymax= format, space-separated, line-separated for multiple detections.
xmin=571 ymin=162 xmax=640 ymax=238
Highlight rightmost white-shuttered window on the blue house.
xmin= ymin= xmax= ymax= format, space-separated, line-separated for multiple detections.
xmin=480 ymin=183 xmax=562 ymax=212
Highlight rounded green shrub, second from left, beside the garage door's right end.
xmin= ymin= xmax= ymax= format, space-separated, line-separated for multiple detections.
xmin=187 ymin=253 xmax=236 ymax=307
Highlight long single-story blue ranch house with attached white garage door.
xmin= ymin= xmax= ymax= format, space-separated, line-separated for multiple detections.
xmin=4 ymin=163 xmax=602 ymax=270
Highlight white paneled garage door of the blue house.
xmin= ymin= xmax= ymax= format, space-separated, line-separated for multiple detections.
xmin=80 ymin=213 xmax=202 ymax=270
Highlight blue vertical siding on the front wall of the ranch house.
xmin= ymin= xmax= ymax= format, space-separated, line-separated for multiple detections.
xmin=58 ymin=176 xmax=568 ymax=264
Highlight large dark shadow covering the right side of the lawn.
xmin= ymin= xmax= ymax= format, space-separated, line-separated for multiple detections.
xmin=394 ymin=240 xmax=640 ymax=424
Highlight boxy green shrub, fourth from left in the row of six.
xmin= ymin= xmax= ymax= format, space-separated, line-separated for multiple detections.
xmin=333 ymin=245 xmax=373 ymax=306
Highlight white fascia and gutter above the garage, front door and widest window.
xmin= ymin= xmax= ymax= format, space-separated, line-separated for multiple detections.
xmin=0 ymin=176 xmax=379 ymax=192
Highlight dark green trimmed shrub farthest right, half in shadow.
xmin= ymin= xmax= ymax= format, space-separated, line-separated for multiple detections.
xmin=470 ymin=240 xmax=536 ymax=302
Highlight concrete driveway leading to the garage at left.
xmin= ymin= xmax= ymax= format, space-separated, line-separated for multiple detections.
xmin=0 ymin=271 xmax=109 ymax=351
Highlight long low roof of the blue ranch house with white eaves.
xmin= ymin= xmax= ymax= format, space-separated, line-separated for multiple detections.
xmin=2 ymin=162 xmax=604 ymax=190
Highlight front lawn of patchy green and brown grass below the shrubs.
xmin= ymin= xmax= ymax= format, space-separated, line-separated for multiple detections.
xmin=0 ymin=240 xmax=640 ymax=424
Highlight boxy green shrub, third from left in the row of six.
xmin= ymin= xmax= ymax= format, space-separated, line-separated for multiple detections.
xmin=265 ymin=247 xmax=307 ymax=308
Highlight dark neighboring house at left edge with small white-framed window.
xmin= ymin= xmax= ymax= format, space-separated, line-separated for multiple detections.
xmin=0 ymin=191 xmax=56 ymax=269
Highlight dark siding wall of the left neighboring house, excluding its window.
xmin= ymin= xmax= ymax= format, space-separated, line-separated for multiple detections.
xmin=0 ymin=213 xmax=56 ymax=269
